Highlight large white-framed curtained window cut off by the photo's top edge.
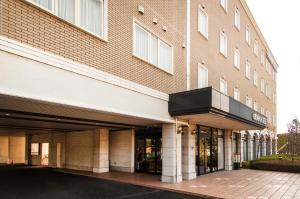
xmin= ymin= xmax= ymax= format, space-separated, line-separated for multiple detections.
xmin=27 ymin=0 xmax=108 ymax=40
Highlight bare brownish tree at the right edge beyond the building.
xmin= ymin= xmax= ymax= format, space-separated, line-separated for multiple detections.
xmin=288 ymin=118 xmax=300 ymax=160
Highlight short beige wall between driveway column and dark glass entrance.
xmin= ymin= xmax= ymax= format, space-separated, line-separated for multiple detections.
xmin=109 ymin=130 xmax=134 ymax=172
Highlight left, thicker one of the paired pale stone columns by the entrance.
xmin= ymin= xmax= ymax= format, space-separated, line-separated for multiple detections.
xmin=161 ymin=124 xmax=182 ymax=183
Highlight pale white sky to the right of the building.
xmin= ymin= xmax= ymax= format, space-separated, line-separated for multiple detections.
xmin=246 ymin=0 xmax=300 ymax=133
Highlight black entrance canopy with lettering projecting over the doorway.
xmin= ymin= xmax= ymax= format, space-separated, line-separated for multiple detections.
xmin=169 ymin=87 xmax=267 ymax=130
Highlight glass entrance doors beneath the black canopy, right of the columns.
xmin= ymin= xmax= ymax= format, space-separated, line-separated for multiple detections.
xmin=196 ymin=126 xmax=224 ymax=175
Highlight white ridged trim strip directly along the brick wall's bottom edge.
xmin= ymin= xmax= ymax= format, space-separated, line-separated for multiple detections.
xmin=0 ymin=36 xmax=169 ymax=101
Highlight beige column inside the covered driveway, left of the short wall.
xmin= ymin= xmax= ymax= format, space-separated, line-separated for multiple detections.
xmin=93 ymin=129 xmax=109 ymax=173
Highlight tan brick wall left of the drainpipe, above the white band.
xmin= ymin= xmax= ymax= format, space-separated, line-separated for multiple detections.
xmin=0 ymin=0 xmax=185 ymax=93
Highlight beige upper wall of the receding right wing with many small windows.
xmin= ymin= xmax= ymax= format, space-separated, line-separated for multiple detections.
xmin=191 ymin=0 xmax=276 ymax=131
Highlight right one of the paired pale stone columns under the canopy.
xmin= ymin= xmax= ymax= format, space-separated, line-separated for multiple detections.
xmin=182 ymin=125 xmax=197 ymax=180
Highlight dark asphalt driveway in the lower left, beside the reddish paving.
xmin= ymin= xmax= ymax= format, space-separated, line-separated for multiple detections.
xmin=0 ymin=167 xmax=204 ymax=199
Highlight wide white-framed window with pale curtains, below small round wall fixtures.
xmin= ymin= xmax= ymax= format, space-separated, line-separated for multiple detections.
xmin=133 ymin=23 xmax=173 ymax=72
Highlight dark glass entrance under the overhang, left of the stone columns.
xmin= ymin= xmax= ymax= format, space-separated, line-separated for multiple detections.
xmin=135 ymin=128 xmax=162 ymax=174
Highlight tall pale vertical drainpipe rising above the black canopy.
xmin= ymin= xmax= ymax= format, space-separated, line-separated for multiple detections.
xmin=186 ymin=0 xmax=191 ymax=90
